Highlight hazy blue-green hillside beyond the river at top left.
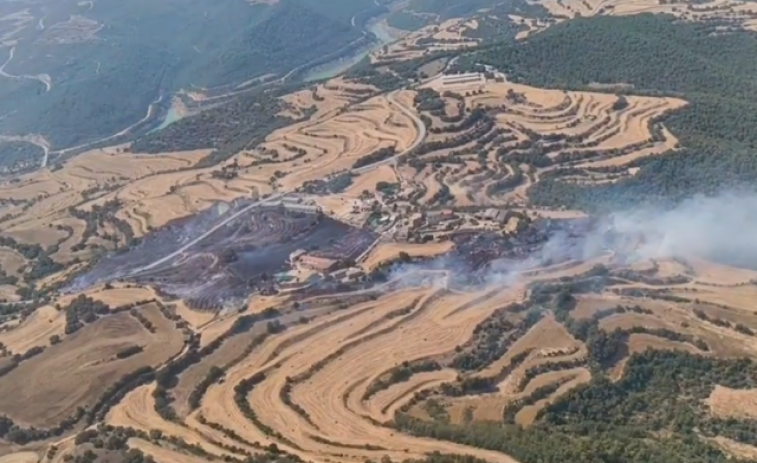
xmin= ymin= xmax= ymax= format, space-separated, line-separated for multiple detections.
xmin=0 ymin=0 xmax=375 ymax=149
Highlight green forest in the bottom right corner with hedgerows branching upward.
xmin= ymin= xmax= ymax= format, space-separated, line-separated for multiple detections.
xmin=394 ymin=288 xmax=757 ymax=463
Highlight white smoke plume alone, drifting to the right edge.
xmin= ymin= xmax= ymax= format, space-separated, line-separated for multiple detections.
xmin=392 ymin=191 xmax=757 ymax=286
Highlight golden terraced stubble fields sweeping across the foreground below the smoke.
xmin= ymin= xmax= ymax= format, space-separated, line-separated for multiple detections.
xmin=60 ymin=254 xmax=757 ymax=462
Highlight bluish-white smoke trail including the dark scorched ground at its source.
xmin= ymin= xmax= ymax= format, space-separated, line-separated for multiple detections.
xmin=391 ymin=192 xmax=757 ymax=285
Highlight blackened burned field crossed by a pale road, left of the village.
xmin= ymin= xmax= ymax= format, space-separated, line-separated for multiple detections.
xmin=79 ymin=204 xmax=376 ymax=310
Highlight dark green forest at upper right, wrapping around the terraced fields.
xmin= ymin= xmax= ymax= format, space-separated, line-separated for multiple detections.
xmin=460 ymin=15 xmax=757 ymax=210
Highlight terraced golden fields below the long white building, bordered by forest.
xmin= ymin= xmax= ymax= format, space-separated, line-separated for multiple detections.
xmin=412 ymin=79 xmax=686 ymax=207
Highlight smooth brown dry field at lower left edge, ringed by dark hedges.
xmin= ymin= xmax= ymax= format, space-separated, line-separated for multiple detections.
xmin=0 ymin=307 xmax=184 ymax=427
